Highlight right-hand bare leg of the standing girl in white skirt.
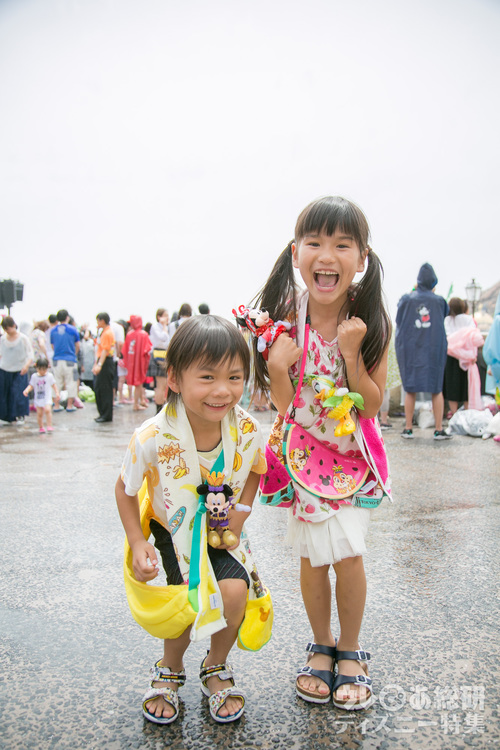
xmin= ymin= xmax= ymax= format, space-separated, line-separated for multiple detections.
xmin=333 ymin=556 xmax=368 ymax=703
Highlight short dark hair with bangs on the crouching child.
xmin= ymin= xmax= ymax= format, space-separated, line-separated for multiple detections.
xmin=166 ymin=315 xmax=250 ymax=403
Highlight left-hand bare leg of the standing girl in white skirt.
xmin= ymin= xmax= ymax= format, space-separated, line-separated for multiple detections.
xmin=298 ymin=557 xmax=335 ymax=698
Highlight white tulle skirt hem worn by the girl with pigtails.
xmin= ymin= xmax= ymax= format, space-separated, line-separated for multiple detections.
xmin=287 ymin=505 xmax=372 ymax=567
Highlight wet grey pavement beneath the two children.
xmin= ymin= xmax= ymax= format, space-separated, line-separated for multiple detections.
xmin=0 ymin=404 xmax=500 ymax=750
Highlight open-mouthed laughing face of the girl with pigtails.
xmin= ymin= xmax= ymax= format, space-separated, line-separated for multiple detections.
xmin=292 ymin=230 xmax=366 ymax=310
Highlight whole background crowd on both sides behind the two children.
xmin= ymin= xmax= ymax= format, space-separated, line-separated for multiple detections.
xmin=0 ymin=284 xmax=500 ymax=440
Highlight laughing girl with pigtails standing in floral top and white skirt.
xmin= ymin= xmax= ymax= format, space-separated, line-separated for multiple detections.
xmin=246 ymin=197 xmax=391 ymax=710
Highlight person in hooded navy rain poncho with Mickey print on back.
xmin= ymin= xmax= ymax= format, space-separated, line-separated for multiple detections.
xmin=396 ymin=263 xmax=451 ymax=440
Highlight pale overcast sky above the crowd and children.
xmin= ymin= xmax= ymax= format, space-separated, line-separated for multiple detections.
xmin=0 ymin=0 xmax=500 ymax=323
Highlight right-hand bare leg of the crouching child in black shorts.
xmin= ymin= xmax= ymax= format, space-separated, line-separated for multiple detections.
xmin=205 ymin=578 xmax=248 ymax=716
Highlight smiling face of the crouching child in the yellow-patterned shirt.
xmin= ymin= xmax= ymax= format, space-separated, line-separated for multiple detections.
xmin=167 ymin=358 xmax=245 ymax=438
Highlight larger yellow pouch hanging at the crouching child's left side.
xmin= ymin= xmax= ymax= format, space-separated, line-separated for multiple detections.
xmin=123 ymin=482 xmax=196 ymax=639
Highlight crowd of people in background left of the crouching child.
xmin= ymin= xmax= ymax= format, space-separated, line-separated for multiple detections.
xmin=0 ymin=303 xmax=210 ymax=433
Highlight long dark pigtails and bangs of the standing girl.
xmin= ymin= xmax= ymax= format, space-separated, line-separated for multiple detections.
xmin=251 ymin=196 xmax=391 ymax=391
